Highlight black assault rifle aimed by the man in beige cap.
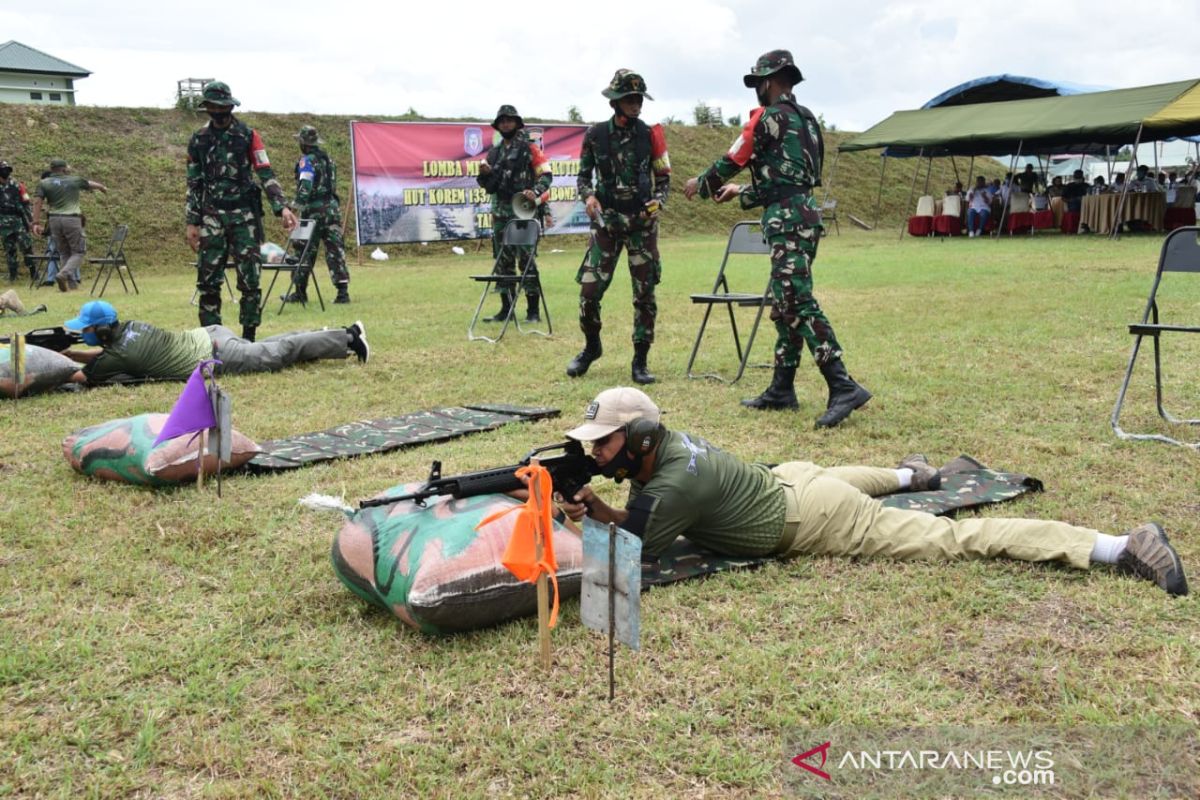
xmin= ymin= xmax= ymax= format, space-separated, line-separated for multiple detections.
xmin=359 ymin=439 xmax=600 ymax=509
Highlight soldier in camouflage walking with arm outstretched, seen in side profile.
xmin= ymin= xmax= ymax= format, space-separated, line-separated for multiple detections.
xmin=684 ymin=50 xmax=871 ymax=428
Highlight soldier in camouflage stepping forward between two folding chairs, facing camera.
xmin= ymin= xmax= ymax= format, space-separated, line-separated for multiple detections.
xmin=566 ymin=70 xmax=671 ymax=384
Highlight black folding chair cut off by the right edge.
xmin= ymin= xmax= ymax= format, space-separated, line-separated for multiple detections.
xmin=1111 ymin=227 xmax=1200 ymax=450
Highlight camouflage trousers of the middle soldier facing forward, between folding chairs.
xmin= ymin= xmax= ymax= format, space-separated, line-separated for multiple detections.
xmin=575 ymin=211 xmax=662 ymax=344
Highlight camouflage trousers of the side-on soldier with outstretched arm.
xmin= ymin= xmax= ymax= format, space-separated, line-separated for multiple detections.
xmin=763 ymin=215 xmax=841 ymax=367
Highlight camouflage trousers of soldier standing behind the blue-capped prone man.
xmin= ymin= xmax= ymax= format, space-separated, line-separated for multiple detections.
xmin=196 ymin=209 xmax=263 ymax=327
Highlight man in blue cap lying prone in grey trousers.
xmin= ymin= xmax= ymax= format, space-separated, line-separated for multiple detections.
xmin=62 ymin=300 xmax=370 ymax=384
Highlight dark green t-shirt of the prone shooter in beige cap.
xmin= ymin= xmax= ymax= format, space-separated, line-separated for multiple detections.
xmin=625 ymin=431 xmax=787 ymax=555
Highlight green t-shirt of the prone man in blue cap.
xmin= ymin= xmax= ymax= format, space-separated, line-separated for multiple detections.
xmin=83 ymin=321 xmax=212 ymax=384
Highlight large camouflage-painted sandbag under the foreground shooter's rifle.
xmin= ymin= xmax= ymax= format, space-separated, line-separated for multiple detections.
xmin=332 ymin=487 xmax=583 ymax=633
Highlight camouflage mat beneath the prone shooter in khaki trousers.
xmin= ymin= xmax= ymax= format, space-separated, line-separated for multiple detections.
xmin=642 ymin=456 xmax=1043 ymax=591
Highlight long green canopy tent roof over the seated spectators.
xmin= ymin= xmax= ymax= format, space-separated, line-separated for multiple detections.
xmin=838 ymin=79 xmax=1200 ymax=237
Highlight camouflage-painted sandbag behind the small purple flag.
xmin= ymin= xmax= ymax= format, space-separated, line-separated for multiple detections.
xmin=62 ymin=414 xmax=258 ymax=486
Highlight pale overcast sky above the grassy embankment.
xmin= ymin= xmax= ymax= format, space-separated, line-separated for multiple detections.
xmin=0 ymin=0 xmax=1200 ymax=131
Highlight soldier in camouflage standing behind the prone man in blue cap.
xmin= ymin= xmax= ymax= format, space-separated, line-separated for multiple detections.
xmin=187 ymin=80 xmax=296 ymax=342
